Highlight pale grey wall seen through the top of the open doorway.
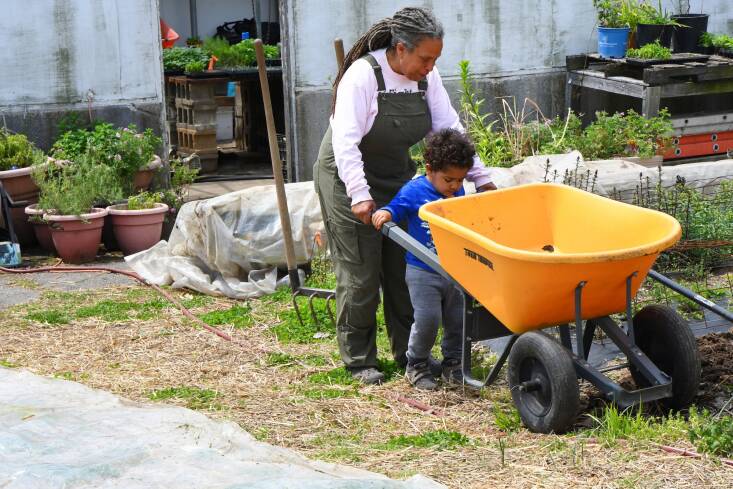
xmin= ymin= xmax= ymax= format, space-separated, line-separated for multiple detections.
xmin=160 ymin=0 xmax=278 ymax=46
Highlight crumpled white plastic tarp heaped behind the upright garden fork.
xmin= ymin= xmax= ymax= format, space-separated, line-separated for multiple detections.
xmin=125 ymin=182 xmax=325 ymax=299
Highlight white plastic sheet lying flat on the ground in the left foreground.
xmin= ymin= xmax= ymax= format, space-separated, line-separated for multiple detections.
xmin=0 ymin=367 xmax=445 ymax=489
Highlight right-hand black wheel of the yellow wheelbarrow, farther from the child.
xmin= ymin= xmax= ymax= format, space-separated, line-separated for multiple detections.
xmin=629 ymin=304 xmax=700 ymax=409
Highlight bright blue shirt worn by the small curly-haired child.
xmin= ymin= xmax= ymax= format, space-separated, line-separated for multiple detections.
xmin=382 ymin=176 xmax=466 ymax=272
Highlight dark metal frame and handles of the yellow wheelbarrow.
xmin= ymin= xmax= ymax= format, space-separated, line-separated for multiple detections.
xmin=382 ymin=222 xmax=733 ymax=408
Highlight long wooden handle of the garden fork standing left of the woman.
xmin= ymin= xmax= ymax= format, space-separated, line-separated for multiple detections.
xmin=254 ymin=39 xmax=300 ymax=284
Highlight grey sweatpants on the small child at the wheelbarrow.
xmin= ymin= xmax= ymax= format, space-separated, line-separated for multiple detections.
xmin=405 ymin=264 xmax=463 ymax=364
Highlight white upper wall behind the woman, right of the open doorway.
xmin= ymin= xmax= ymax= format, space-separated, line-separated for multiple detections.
xmin=286 ymin=0 xmax=733 ymax=89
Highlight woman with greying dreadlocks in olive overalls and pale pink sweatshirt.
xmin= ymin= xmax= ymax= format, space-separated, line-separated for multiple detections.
xmin=313 ymin=8 xmax=496 ymax=384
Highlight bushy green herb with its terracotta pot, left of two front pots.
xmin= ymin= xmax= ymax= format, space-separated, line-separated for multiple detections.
xmin=33 ymin=148 xmax=121 ymax=263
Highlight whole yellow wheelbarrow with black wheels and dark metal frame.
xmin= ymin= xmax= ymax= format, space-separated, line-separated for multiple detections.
xmin=383 ymin=183 xmax=720 ymax=433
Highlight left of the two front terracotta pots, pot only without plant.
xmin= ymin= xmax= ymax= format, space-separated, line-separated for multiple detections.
xmin=43 ymin=207 xmax=107 ymax=263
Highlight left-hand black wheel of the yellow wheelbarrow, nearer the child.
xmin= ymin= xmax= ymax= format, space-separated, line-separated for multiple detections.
xmin=507 ymin=332 xmax=580 ymax=433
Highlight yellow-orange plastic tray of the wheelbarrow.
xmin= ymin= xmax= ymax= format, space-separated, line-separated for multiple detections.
xmin=419 ymin=183 xmax=681 ymax=334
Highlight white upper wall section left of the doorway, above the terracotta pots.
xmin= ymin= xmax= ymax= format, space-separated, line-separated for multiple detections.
xmin=0 ymin=0 xmax=163 ymax=110
